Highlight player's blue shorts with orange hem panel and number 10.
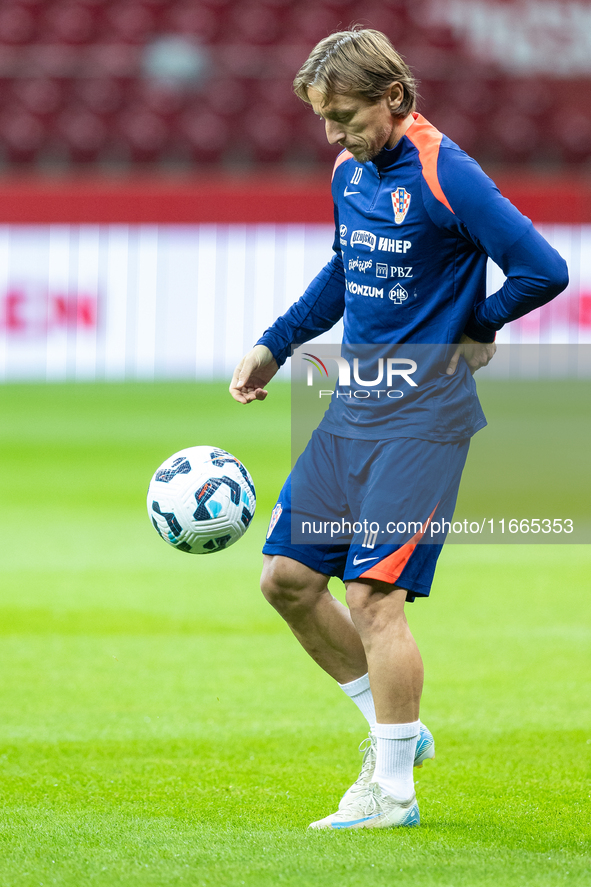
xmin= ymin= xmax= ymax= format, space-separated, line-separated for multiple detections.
xmin=263 ymin=429 xmax=470 ymax=600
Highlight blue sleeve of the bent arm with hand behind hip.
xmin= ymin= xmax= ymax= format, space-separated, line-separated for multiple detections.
xmin=438 ymin=146 xmax=568 ymax=342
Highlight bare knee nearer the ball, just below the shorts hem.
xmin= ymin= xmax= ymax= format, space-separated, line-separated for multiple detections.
xmin=261 ymin=555 xmax=327 ymax=613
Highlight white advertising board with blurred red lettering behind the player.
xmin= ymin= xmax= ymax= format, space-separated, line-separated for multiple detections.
xmin=0 ymin=224 xmax=591 ymax=381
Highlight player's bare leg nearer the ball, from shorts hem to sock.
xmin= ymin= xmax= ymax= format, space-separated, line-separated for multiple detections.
xmin=261 ymin=555 xmax=367 ymax=684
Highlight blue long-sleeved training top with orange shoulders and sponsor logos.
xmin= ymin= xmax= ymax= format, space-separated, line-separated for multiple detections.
xmin=257 ymin=114 xmax=568 ymax=440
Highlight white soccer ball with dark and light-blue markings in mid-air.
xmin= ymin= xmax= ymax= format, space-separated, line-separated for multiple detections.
xmin=148 ymin=447 xmax=256 ymax=554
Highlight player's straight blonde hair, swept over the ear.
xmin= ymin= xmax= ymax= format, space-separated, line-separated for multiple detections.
xmin=293 ymin=28 xmax=417 ymax=117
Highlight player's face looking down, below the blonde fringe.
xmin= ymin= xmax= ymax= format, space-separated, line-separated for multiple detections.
xmin=308 ymin=84 xmax=402 ymax=163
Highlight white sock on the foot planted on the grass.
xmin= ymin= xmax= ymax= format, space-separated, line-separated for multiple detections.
xmin=372 ymin=721 xmax=421 ymax=801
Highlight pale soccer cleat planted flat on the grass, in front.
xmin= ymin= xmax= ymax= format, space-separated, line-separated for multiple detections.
xmin=308 ymin=782 xmax=421 ymax=830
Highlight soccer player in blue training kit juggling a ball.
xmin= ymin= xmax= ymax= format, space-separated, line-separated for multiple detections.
xmin=230 ymin=29 xmax=568 ymax=829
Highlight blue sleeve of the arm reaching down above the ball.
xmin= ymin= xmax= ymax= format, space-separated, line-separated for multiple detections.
xmin=256 ymin=251 xmax=345 ymax=366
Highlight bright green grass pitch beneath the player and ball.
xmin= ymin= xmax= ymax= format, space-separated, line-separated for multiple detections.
xmin=0 ymin=382 xmax=591 ymax=887
